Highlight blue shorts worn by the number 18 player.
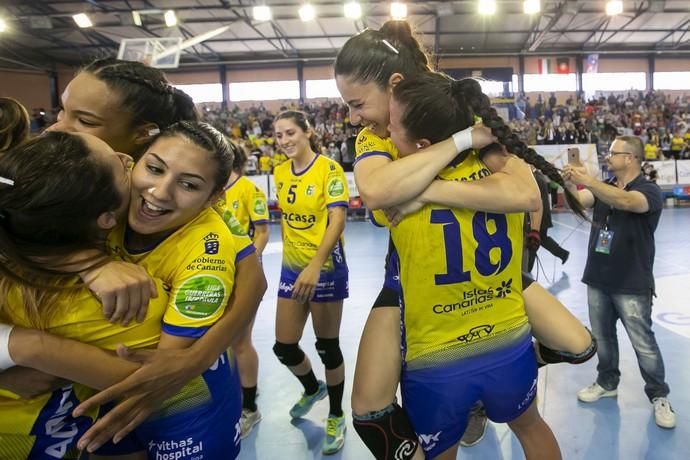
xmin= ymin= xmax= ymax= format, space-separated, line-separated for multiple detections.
xmin=401 ymin=336 xmax=537 ymax=458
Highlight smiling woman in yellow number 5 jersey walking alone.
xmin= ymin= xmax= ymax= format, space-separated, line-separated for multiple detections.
xmin=273 ymin=111 xmax=348 ymax=454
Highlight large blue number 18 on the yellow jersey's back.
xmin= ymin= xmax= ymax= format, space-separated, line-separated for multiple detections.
xmin=431 ymin=209 xmax=513 ymax=285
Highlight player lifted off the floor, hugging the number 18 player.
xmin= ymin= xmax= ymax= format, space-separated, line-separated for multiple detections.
xmin=335 ymin=21 xmax=591 ymax=458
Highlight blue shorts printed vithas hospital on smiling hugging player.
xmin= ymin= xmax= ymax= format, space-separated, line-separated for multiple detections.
xmin=96 ymin=353 xmax=242 ymax=460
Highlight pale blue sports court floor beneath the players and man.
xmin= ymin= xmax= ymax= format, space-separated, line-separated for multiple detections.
xmin=240 ymin=208 xmax=690 ymax=460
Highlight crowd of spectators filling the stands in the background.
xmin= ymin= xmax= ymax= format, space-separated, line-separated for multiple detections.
xmin=31 ymin=91 xmax=690 ymax=174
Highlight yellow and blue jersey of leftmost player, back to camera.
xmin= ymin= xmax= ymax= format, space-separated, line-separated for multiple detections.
xmin=0 ymin=280 xmax=168 ymax=459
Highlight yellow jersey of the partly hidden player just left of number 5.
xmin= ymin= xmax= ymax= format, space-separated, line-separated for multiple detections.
xmin=215 ymin=176 xmax=268 ymax=237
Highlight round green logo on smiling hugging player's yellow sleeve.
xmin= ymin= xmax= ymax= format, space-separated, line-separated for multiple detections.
xmin=175 ymin=275 xmax=225 ymax=320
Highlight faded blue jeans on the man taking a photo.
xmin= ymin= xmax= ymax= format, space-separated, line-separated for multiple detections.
xmin=587 ymin=286 xmax=670 ymax=401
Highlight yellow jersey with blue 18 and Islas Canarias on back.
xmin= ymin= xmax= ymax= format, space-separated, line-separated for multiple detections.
xmin=391 ymin=152 xmax=529 ymax=369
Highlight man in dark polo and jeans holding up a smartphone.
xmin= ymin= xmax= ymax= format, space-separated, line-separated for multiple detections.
xmin=563 ymin=136 xmax=676 ymax=428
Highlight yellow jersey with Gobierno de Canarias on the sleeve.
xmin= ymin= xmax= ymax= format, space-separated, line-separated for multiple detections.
xmin=108 ymin=208 xmax=254 ymax=338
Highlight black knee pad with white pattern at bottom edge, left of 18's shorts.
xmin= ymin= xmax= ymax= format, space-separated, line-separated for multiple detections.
xmin=352 ymin=403 xmax=419 ymax=460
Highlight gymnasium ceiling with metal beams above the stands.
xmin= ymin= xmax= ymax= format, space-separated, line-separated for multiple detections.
xmin=0 ymin=0 xmax=690 ymax=70
